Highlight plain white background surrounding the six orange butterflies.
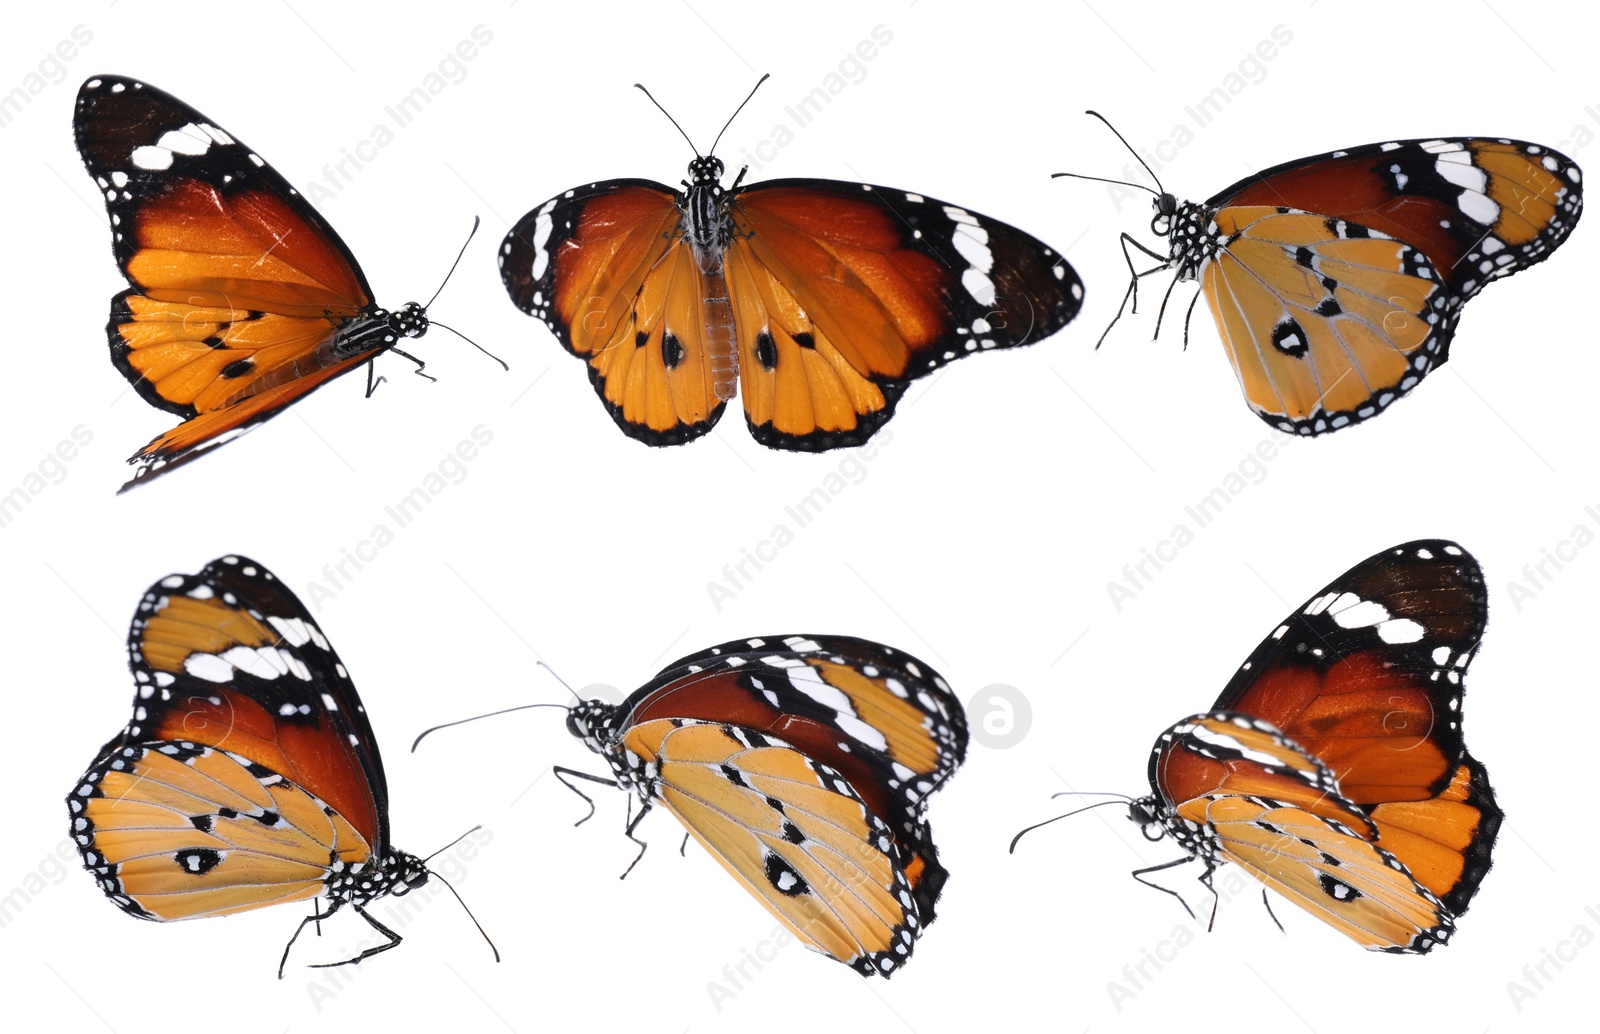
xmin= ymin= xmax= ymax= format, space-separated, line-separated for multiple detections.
xmin=0 ymin=0 xmax=1600 ymax=1034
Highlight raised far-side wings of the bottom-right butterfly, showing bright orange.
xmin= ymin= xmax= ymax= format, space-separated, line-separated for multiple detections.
xmin=1216 ymin=539 xmax=1501 ymax=914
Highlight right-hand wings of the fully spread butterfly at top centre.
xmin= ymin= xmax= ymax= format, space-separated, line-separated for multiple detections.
xmin=726 ymin=179 xmax=1083 ymax=451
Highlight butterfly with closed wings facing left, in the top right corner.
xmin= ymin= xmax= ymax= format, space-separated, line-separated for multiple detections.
xmin=1059 ymin=112 xmax=1582 ymax=435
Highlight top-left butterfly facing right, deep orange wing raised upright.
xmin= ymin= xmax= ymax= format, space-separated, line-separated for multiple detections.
xmin=72 ymin=75 xmax=486 ymax=491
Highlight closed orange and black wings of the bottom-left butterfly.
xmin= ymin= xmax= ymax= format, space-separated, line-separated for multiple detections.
xmin=67 ymin=555 xmax=389 ymax=919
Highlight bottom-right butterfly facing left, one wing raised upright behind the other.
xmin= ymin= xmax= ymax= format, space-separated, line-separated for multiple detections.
xmin=1013 ymin=539 xmax=1501 ymax=954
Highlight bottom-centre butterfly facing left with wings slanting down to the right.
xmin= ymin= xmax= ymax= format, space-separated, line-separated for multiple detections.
xmin=574 ymin=635 xmax=968 ymax=976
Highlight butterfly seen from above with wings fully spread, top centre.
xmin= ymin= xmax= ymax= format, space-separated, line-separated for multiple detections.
xmin=499 ymin=75 xmax=1083 ymax=451
